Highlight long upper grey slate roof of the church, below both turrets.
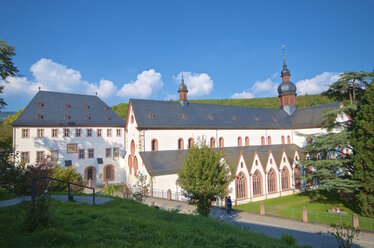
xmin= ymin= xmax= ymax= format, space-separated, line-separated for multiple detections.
xmin=130 ymin=99 xmax=340 ymax=129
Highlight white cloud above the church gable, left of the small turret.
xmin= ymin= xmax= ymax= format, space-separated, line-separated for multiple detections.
xmin=117 ymin=69 xmax=163 ymax=98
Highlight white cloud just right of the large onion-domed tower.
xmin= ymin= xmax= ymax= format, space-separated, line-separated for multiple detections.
xmin=296 ymin=72 xmax=340 ymax=95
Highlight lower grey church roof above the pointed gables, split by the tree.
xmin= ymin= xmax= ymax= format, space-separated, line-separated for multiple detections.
xmin=140 ymin=144 xmax=303 ymax=176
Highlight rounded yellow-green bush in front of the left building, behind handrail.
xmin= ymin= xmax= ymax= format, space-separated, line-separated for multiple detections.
xmin=51 ymin=165 xmax=83 ymax=192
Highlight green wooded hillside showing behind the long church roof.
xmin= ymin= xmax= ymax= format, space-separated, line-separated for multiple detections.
xmin=112 ymin=94 xmax=335 ymax=119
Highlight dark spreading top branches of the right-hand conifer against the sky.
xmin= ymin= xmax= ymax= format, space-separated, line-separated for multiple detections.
xmin=323 ymin=71 xmax=374 ymax=104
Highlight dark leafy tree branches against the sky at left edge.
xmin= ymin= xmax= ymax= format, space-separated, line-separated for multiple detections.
xmin=0 ymin=40 xmax=18 ymax=110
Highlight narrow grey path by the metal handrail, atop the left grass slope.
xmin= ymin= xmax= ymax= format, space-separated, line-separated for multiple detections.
xmin=0 ymin=195 xmax=113 ymax=207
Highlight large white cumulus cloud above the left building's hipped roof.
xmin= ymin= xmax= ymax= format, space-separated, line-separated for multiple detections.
xmin=4 ymin=58 xmax=117 ymax=98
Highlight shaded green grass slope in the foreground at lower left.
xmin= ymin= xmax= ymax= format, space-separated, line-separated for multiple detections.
xmin=0 ymin=198 xmax=298 ymax=247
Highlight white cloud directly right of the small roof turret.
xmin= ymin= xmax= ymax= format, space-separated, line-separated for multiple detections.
xmin=175 ymin=71 xmax=214 ymax=97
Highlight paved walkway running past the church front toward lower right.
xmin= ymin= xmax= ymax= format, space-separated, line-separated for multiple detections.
xmin=146 ymin=198 xmax=374 ymax=247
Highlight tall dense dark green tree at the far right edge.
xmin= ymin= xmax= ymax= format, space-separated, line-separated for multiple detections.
xmin=351 ymin=80 xmax=374 ymax=217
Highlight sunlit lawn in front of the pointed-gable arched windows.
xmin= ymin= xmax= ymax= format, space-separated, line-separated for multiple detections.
xmin=237 ymin=190 xmax=374 ymax=231
